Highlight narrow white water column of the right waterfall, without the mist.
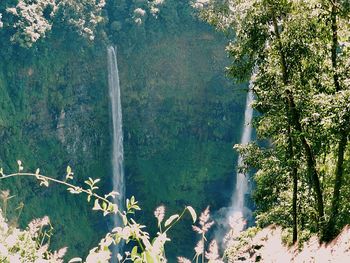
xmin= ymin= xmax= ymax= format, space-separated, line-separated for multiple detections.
xmin=231 ymin=86 xmax=254 ymax=216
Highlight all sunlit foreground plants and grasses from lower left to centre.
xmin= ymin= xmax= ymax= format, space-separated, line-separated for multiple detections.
xmin=0 ymin=164 xmax=227 ymax=263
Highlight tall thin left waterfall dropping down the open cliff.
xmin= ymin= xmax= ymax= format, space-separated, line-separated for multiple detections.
xmin=107 ymin=46 xmax=125 ymax=228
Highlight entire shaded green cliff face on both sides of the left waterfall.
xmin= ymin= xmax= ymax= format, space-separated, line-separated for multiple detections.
xmin=0 ymin=1 xmax=245 ymax=259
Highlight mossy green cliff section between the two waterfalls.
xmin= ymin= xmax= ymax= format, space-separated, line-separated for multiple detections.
xmin=119 ymin=24 xmax=244 ymax=258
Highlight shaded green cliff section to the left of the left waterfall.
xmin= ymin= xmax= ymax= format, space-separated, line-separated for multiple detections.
xmin=0 ymin=38 xmax=110 ymax=254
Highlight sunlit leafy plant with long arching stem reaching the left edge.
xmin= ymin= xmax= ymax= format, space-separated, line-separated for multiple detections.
xmin=0 ymin=160 xmax=200 ymax=263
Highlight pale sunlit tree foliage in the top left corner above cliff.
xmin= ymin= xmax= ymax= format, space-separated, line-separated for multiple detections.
xmin=0 ymin=0 xmax=105 ymax=47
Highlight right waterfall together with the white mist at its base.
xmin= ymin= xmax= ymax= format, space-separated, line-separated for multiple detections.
xmin=213 ymin=87 xmax=254 ymax=249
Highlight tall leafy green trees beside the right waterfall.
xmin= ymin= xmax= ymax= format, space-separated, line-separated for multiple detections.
xmin=198 ymin=0 xmax=350 ymax=242
